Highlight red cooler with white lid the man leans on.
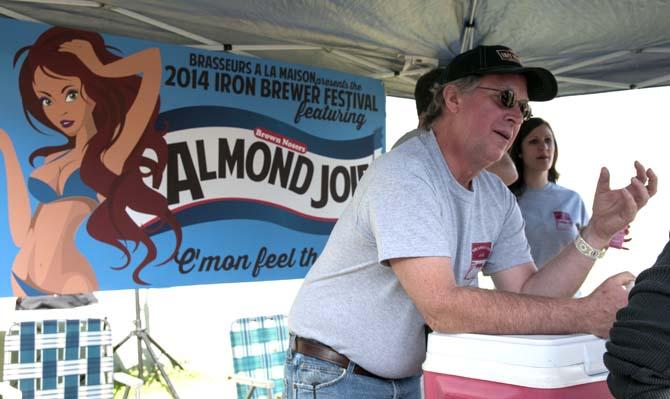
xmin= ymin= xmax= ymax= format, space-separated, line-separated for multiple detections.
xmin=423 ymin=333 xmax=612 ymax=399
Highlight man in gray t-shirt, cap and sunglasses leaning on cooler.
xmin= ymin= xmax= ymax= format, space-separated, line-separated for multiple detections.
xmin=285 ymin=46 xmax=656 ymax=398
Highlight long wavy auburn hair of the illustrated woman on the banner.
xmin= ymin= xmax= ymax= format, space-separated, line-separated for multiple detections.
xmin=14 ymin=27 xmax=181 ymax=284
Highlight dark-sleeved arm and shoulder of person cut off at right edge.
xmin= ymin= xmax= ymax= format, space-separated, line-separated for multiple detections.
xmin=605 ymin=236 xmax=670 ymax=399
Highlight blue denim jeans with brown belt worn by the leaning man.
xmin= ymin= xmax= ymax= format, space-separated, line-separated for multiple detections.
xmin=283 ymin=340 xmax=421 ymax=399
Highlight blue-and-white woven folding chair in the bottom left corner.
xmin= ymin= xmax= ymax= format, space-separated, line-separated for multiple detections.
xmin=2 ymin=308 xmax=142 ymax=399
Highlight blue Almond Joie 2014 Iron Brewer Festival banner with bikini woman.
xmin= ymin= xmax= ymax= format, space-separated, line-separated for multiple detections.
xmin=0 ymin=19 xmax=385 ymax=296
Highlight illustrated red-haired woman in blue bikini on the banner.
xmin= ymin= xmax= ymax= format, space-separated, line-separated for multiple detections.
xmin=0 ymin=28 xmax=181 ymax=296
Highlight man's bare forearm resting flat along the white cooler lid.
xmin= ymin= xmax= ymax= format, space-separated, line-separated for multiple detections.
xmin=426 ymin=287 xmax=590 ymax=334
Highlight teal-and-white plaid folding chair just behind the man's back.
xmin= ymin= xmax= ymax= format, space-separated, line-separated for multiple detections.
xmin=229 ymin=315 xmax=288 ymax=399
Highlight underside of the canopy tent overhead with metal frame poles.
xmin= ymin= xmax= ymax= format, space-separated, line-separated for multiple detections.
xmin=0 ymin=0 xmax=670 ymax=97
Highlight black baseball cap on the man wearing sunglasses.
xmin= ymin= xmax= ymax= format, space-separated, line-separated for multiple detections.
xmin=440 ymin=46 xmax=558 ymax=101
